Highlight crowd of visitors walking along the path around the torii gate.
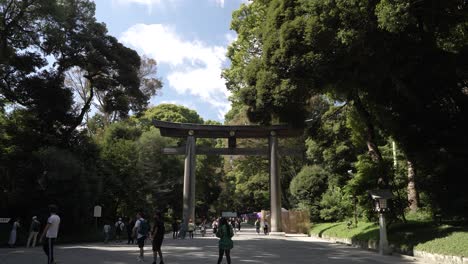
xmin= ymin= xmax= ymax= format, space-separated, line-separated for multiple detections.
xmin=8 ymin=209 xmax=269 ymax=264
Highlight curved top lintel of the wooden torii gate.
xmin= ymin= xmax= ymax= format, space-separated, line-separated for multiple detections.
xmin=153 ymin=120 xmax=303 ymax=138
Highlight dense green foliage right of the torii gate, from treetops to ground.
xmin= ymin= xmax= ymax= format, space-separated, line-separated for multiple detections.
xmin=223 ymin=0 xmax=468 ymax=220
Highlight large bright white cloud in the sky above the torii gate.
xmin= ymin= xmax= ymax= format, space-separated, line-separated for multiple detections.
xmin=120 ymin=24 xmax=230 ymax=119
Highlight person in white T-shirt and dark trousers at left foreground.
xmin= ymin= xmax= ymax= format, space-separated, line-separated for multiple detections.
xmin=41 ymin=204 xmax=60 ymax=264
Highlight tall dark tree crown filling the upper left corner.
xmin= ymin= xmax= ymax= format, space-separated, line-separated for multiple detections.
xmin=0 ymin=0 xmax=144 ymax=136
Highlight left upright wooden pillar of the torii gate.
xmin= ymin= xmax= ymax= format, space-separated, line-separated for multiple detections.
xmin=182 ymin=130 xmax=195 ymax=226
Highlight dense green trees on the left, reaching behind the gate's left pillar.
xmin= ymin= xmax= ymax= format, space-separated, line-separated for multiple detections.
xmin=0 ymin=0 xmax=224 ymax=240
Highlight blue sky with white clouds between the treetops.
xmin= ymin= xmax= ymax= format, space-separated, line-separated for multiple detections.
xmin=91 ymin=0 xmax=247 ymax=121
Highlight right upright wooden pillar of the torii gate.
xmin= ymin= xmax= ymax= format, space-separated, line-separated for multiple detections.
xmin=268 ymin=131 xmax=282 ymax=234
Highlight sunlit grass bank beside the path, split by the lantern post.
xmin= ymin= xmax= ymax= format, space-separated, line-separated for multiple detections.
xmin=310 ymin=221 xmax=468 ymax=256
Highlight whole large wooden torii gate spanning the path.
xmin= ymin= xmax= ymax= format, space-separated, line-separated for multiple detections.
xmin=153 ymin=120 xmax=303 ymax=234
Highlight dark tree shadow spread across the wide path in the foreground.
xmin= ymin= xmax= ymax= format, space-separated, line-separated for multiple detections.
xmin=0 ymin=228 xmax=424 ymax=264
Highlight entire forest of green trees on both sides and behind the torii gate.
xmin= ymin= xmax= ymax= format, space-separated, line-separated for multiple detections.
xmin=0 ymin=0 xmax=468 ymax=239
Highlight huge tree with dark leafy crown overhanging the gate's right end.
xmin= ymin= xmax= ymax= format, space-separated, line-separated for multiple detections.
xmin=225 ymin=0 xmax=468 ymax=212
